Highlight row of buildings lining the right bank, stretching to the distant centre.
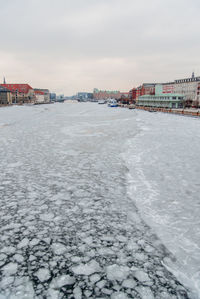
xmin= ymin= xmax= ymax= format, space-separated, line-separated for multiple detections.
xmin=75 ymin=73 xmax=200 ymax=108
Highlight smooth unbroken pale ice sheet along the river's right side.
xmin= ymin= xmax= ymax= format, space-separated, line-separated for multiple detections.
xmin=123 ymin=111 xmax=200 ymax=298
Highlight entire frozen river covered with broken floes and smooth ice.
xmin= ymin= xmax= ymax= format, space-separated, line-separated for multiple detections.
xmin=0 ymin=103 xmax=200 ymax=299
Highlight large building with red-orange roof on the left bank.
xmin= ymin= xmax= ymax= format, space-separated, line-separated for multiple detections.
xmin=1 ymin=84 xmax=35 ymax=104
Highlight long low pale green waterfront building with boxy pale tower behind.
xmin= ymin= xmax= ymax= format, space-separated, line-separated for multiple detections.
xmin=137 ymin=84 xmax=185 ymax=108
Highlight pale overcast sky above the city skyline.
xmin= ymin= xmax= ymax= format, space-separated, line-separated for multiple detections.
xmin=0 ymin=0 xmax=200 ymax=95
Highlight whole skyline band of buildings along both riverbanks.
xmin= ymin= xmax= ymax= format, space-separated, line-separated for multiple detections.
xmin=0 ymin=73 xmax=200 ymax=108
